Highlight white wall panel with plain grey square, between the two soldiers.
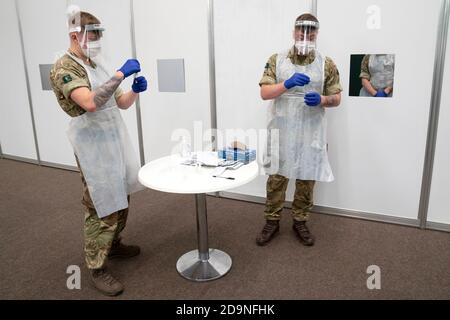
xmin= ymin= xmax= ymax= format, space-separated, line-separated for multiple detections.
xmin=134 ymin=0 xmax=210 ymax=162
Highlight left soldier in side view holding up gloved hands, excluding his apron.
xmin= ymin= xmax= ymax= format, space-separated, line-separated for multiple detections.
xmin=50 ymin=8 xmax=147 ymax=296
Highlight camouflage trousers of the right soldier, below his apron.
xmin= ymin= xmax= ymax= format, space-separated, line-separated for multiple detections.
xmin=264 ymin=174 xmax=315 ymax=221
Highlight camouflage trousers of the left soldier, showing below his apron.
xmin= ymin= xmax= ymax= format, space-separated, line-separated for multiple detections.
xmin=76 ymin=159 xmax=130 ymax=269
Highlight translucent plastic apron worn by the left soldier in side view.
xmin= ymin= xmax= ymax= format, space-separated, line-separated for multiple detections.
xmin=67 ymin=55 xmax=143 ymax=218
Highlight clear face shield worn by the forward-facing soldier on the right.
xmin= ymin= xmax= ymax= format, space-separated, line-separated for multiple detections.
xmin=294 ymin=20 xmax=319 ymax=56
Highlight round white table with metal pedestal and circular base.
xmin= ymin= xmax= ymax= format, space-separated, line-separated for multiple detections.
xmin=139 ymin=155 xmax=258 ymax=281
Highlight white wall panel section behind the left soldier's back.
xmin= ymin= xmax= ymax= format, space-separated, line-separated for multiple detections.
xmin=18 ymin=0 xmax=75 ymax=166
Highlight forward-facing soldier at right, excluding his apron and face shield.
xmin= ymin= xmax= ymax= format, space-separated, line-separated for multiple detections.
xmin=256 ymin=14 xmax=342 ymax=246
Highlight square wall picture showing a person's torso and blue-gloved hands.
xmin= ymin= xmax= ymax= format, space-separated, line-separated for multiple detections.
xmin=349 ymin=54 xmax=395 ymax=98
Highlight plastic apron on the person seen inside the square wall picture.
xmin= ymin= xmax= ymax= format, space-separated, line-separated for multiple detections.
xmin=359 ymin=54 xmax=394 ymax=97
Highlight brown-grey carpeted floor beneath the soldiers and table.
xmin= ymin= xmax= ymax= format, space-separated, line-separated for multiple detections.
xmin=0 ymin=159 xmax=450 ymax=299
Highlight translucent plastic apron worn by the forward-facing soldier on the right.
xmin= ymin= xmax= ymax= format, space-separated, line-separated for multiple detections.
xmin=264 ymin=51 xmax=334 ymax=182
